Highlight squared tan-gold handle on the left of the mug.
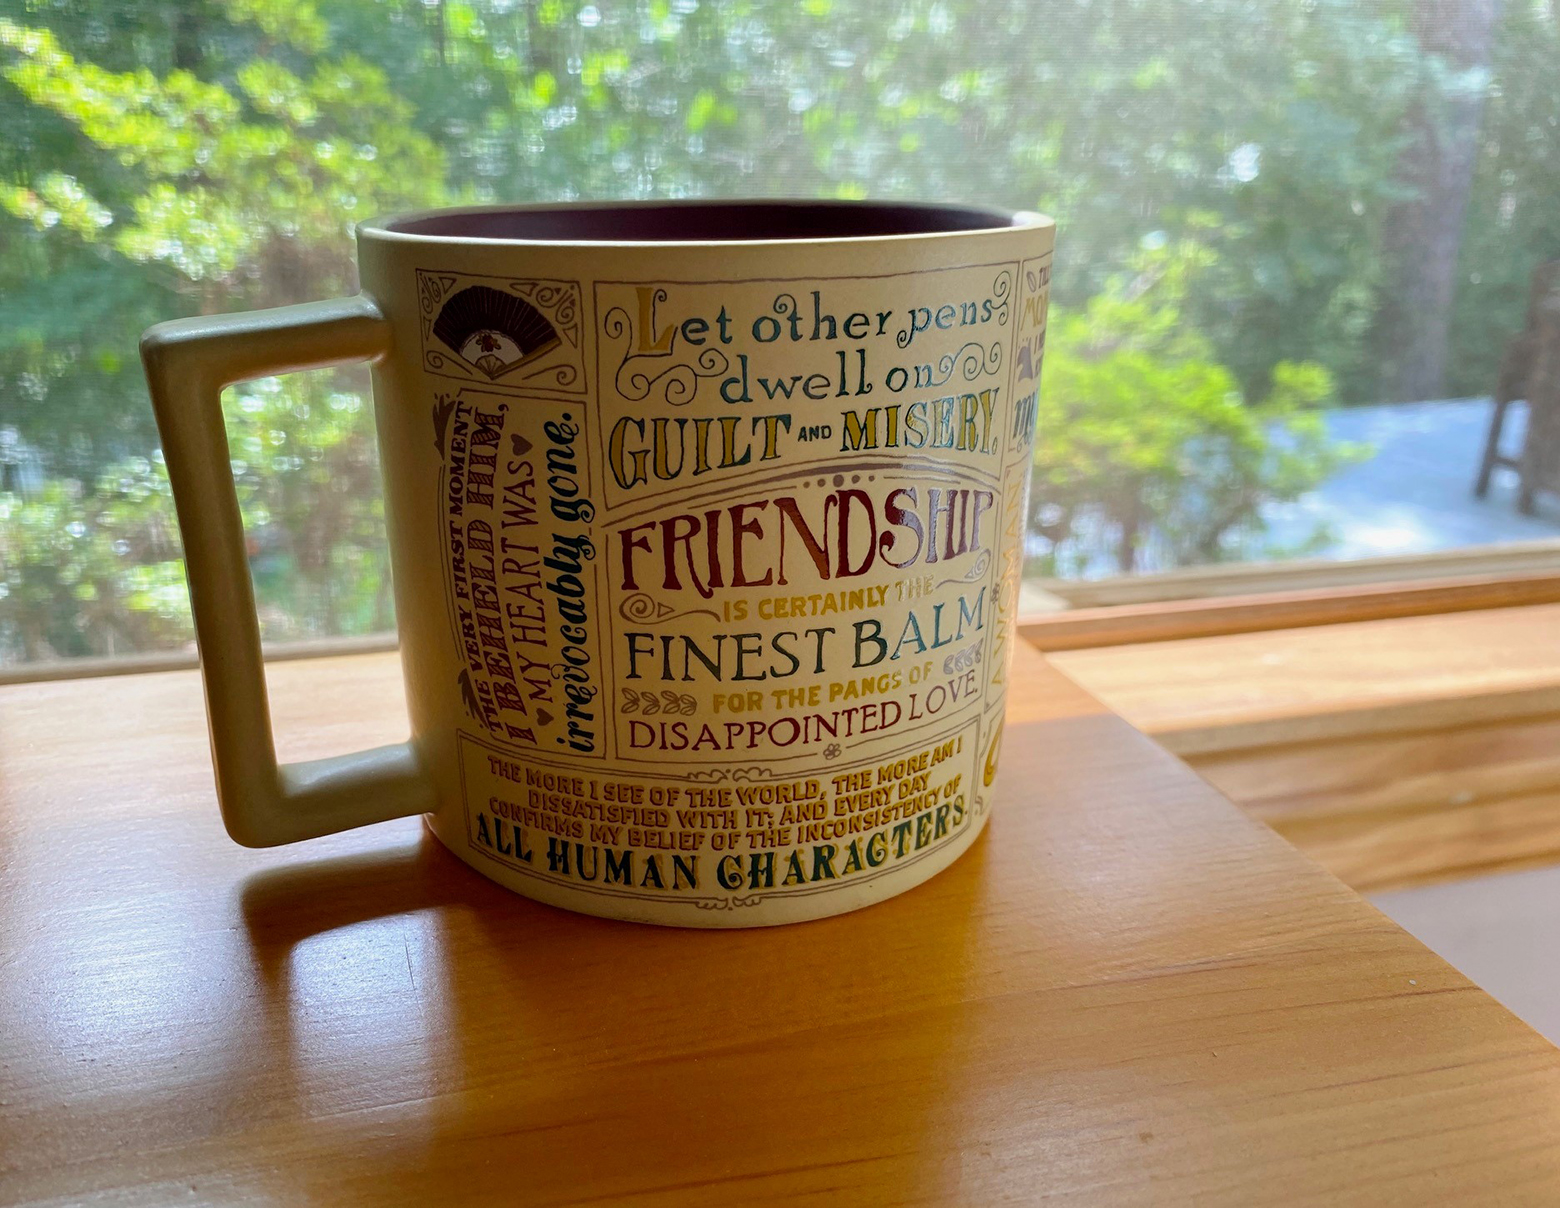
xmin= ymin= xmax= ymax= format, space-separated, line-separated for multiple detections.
xmin=140 ymin=295 xmax=435 ymax=847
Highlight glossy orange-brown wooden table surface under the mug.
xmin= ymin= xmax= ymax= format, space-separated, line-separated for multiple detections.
xmin=9 ymin=639 xmax=1560 ymax=1205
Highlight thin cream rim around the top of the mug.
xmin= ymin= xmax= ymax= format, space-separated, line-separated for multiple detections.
xmin=357 ymin=197 xmax=1056 ymax=250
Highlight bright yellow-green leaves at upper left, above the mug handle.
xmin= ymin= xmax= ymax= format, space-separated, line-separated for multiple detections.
xmin=0 ymin=14 xmax=443 ymax=297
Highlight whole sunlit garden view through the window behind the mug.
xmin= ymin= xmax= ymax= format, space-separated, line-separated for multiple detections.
xmin=0 ymin=0 xmax=1560 ymax=666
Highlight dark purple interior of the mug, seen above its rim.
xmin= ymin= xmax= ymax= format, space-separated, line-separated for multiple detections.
xmin=384 ymin=201 xmax=1016 ymax=243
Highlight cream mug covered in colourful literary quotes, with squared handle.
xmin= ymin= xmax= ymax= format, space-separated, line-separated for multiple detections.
xmin=142 ymin=201 xmax=1055 ymax=927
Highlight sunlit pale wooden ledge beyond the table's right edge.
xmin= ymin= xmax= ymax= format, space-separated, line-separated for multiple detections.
xmin=1055 ymin=606 xmax=1560 ymax=891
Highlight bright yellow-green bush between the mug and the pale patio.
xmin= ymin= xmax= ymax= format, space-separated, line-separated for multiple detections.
xmin=1031 ymin=240 xmax=1353 ymax=574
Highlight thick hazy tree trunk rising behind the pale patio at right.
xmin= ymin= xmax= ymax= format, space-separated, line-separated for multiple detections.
xmin=1376 ymin=0 xmax=1499 ymax=403
